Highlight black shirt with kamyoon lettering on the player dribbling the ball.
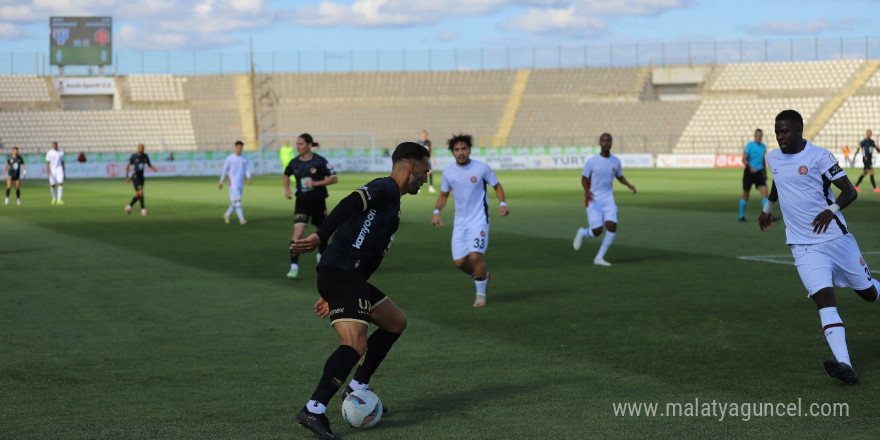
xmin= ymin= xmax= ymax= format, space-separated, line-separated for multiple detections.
xmin=318 ymin=177 xmax=400 ymax=280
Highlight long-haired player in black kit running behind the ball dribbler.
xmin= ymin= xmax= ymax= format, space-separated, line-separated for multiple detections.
xmin=282 ymin=133 xmax=338 ymax=278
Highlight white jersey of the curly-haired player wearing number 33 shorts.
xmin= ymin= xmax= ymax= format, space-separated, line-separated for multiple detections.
xmin=440 ymin=159 xmax=498 ymax=226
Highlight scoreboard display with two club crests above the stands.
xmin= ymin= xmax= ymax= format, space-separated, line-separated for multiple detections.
xmin=49 ymin=17 xmax=113 ymax=66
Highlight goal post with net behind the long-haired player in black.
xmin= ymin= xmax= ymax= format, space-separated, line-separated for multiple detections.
xmin=254 ymin=132 xmax=377 ymax=174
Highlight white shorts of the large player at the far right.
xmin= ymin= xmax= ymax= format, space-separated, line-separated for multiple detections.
xmin=791 ymin=234 xmax=873 ymax=297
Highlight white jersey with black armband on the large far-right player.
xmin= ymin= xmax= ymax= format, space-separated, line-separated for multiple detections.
xmin=767 ymin=141 xmax=847 ymax=245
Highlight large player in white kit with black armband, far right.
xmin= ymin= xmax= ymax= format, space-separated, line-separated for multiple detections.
xmin=758 ymin=110 xmax=880 ymax=384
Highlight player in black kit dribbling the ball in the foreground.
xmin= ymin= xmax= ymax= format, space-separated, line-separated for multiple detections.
xmin=290 ymin=142 xmax=431 ymax=440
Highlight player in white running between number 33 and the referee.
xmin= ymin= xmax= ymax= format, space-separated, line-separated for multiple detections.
xmin=572 ymin=133 xmax=636 ymax=266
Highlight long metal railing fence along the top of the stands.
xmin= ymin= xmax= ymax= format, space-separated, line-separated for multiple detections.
xmin=0 ymin=36 xmax=880 ymax=76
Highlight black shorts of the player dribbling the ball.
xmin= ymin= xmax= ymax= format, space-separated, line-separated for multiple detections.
xmin=318 ymin=266 xmax=388 ymax=325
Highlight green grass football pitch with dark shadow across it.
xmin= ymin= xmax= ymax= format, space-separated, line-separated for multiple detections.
xmin=0 ymin=170 xmax=880 ymax=440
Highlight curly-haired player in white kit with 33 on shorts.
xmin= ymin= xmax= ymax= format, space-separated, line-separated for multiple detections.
xmin=431 ymin=134 xmax=509 ymax=307
